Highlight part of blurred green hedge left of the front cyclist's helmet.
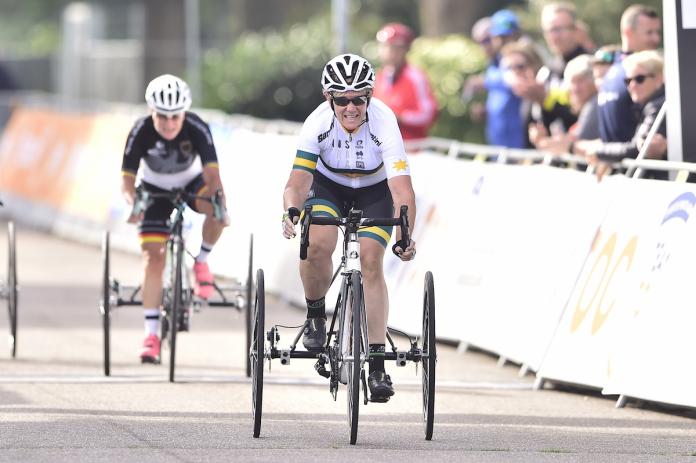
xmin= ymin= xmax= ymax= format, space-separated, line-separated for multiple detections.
xmin=203 ymin=18 xmax=332 ymax=121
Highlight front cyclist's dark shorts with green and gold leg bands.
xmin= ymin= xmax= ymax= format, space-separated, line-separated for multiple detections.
xmin=305 ymin=171 xmax=394 ymax=247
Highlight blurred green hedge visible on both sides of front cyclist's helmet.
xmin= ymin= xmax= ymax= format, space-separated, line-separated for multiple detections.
xmin=203 ymin=18 xmax=486 ymax=142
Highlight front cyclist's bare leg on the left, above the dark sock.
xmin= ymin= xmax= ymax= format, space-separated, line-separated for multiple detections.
xmin=300 ymin=226 xmax=338 ymax=299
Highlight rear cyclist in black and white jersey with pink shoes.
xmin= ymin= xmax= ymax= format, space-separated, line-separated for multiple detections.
xmin=121 ymin=74 xmax=227 ymax=363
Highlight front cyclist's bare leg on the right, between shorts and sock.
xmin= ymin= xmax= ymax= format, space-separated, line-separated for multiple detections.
xmin=356 ymin=237 xmax=389 ymax=344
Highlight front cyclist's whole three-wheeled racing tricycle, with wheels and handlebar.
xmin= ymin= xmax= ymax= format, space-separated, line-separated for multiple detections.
xmin=249 ymin=206 xmax=436 ymax=445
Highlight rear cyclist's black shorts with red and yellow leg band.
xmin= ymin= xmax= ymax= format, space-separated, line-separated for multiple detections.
xmin=139 ymin=174 xmax=206 ymax=244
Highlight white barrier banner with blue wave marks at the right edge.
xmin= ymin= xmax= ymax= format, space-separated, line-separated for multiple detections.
xmin=604 ymin=183 xmax=696 ymax=407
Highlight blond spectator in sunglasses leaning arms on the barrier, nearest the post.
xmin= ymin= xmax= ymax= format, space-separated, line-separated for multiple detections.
xmin=574 ymin=50 xmax=667 ymax=179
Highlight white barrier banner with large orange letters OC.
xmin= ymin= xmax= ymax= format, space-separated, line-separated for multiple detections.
xmin=538 ymin=176 xmax=696 ymax=389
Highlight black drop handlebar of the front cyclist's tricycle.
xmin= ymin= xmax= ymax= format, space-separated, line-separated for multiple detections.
xmin=300 ymin=205 xmax=411 ymax=260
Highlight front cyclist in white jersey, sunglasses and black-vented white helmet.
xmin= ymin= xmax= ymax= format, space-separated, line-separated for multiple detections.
xmin=283 ymin=54 xmax=416 ymax=402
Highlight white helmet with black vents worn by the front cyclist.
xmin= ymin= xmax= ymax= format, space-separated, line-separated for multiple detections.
xmin=321 ymin=53 xmax=375 ymax=92
